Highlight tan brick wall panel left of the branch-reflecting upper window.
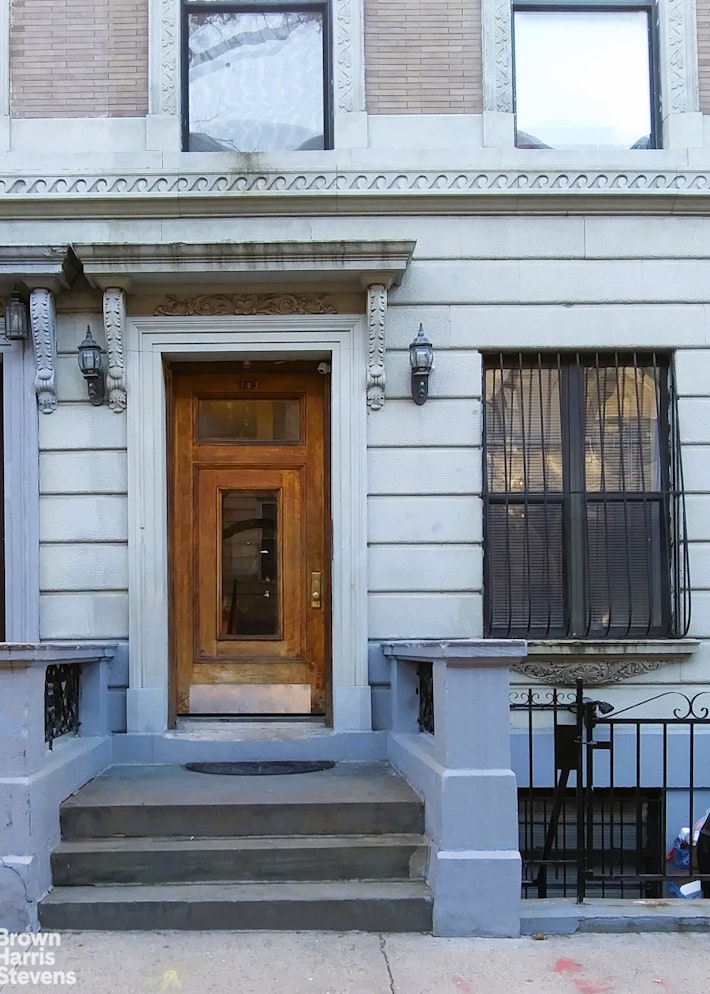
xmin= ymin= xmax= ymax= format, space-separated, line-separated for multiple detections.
xmin=10 ymin=0 xmax=148 ymax=117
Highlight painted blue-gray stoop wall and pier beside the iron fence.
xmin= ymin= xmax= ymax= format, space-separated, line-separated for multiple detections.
xmin=383 ymin=639 xmax=527 ymax=936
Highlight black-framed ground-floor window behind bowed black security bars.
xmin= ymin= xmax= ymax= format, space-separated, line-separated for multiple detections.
xmin=484 ymin=352 xmax=690 ymax=638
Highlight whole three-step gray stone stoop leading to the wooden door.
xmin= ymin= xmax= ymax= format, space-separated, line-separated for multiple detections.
xmin=39 ymin=763 xmax=432 ymax=932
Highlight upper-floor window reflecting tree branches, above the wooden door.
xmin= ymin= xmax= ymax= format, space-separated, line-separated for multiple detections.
xmin=182 ymin=0 xmax=332 ymax=152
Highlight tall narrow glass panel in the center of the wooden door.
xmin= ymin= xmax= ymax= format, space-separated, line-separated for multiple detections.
xmin=219 ymin=490 xmax=281 ymax=639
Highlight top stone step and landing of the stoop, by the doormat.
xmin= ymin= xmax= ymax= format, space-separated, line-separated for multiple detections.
xmin=61 ymin=763 xmax=424 ymax=840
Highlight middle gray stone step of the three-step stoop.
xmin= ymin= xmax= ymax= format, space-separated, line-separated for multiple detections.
xmin=52 ymin=834 xmax=428 ymax=887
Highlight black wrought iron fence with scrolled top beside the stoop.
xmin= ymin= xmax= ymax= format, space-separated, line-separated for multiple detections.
xmin=510 ymin=682 xmax=710 ymax=901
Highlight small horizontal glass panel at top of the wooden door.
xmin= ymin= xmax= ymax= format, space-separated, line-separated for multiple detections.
xmin=197 ymin=398 xmax=301 ymax=442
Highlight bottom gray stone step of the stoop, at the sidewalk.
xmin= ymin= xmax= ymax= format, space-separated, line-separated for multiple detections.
xmin=39 ymin=880 xmax=432 ymax=932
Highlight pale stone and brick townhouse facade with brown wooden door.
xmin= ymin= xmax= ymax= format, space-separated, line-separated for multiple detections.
xmin=0 ymin=0 xmax=710 ymax=925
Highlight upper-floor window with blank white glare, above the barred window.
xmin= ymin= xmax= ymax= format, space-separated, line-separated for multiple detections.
xmin=513 ymin=0 xmax=658 ymax=150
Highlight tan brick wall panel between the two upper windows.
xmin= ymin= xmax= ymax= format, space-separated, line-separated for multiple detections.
xmin=365 ymin=0 xmax=484 ymax=114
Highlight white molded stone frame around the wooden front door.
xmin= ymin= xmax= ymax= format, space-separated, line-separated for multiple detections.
xmin=126 ymin=315 xmax=372 ymax=733
